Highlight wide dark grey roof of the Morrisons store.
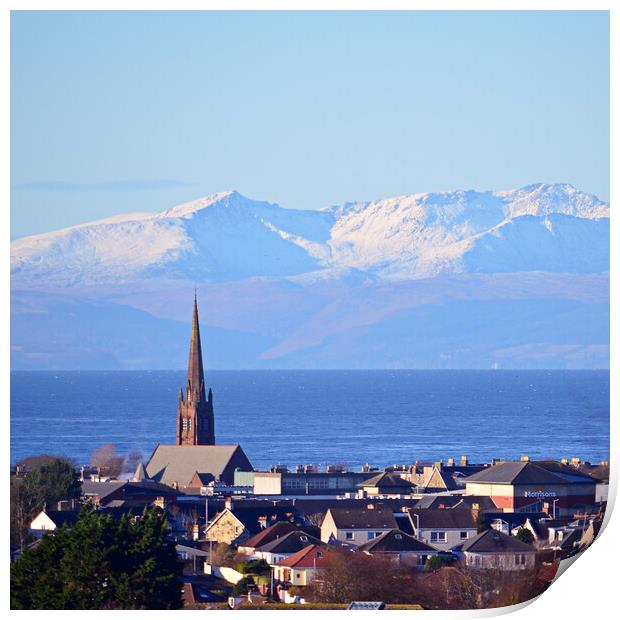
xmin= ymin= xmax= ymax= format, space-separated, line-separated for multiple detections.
xmin=465 ymin=461 xmax=595 ymax=484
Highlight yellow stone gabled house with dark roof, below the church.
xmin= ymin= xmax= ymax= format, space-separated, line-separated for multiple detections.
xmin=207 ymin=506 xmax=295 ymax=545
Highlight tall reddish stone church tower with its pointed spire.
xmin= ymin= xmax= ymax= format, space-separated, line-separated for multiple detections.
xmin=177 ymin=290 xmax=215 ymax=446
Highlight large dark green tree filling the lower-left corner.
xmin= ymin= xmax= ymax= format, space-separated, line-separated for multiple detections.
xmin=11 ymin=508 xmax=182 ymax=609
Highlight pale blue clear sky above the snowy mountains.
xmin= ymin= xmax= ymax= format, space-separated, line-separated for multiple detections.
xmin=11 ymin=11 xmax=609 ymax=238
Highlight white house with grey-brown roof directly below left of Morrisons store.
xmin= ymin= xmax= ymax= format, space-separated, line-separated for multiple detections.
xmin=409 ymin=508 xmax=478 ymax=551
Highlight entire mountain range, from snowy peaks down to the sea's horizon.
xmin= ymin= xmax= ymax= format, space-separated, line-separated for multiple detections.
xmin=11 ymin=184 xmax=609 ymax=368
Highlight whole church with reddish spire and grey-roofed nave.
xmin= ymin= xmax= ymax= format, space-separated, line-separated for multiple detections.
xmin=143 ymin=294 xmax=253 ymax=489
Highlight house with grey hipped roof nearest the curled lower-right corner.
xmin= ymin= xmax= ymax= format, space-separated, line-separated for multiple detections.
xmin=452 ymin=529 xmax=536 ymax=570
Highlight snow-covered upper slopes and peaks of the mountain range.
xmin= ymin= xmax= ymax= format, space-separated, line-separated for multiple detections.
xmin=11 ymin=185 xmax=609 ymax=288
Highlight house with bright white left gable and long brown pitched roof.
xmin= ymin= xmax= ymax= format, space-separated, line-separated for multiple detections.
xmin=321 ymin=504 xmax=398 ymax=545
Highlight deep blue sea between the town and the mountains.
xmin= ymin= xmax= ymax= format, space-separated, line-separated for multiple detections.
xmin=11 ymin=370 xmax=609 ymax=468
